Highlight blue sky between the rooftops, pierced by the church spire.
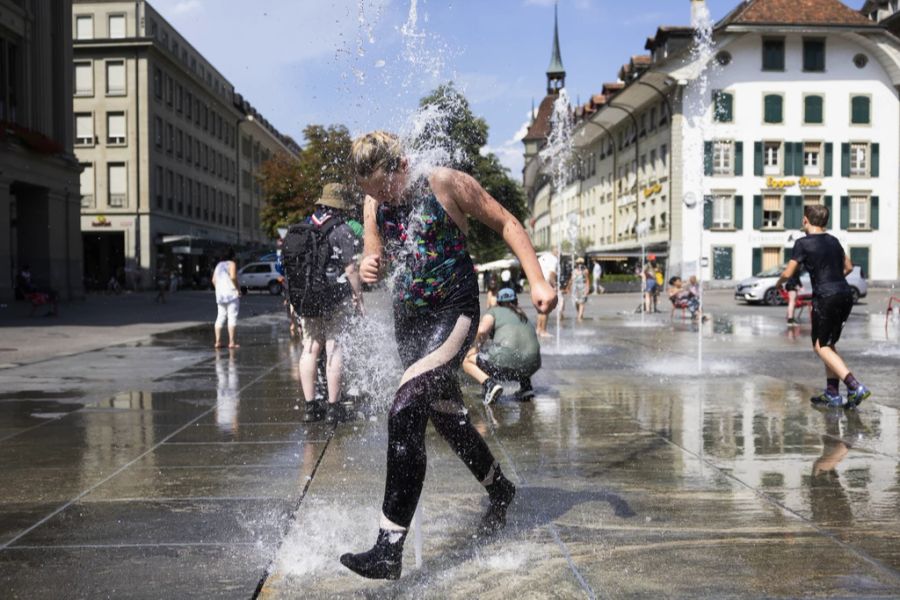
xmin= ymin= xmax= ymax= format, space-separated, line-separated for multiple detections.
xmin=151 ymin=0 xmax=780 ymax=177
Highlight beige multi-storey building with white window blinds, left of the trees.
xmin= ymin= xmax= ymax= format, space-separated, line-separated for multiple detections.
xmin=72 ymin=0 xmax=298 ymax=288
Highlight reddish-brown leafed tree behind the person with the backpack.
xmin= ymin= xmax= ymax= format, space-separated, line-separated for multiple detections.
xmin=257 ymin=125 xmax=353 ymax=238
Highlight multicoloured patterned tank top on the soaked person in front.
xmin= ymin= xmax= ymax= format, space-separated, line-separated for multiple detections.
xmin=377 ymin=191 xmax=478 ymax=313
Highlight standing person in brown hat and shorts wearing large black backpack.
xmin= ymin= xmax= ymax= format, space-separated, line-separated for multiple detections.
xmin=282 ymin=183 xmax=362 ymax=423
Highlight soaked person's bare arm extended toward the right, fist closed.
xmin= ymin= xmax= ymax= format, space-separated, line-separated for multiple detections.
xmin=429 ymin=169 xmax=556 ymax=313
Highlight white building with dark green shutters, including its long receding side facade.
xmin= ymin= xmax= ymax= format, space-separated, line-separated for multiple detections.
xmin=525 ymin=0 xmax=900 ymax=285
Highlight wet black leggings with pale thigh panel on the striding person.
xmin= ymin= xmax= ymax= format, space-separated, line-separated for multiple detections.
xmin=382 ymin=306 xmax=496 ymax=527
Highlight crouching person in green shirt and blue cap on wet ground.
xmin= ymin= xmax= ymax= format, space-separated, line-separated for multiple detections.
xmin=463 ymin=288 xmax=541 ymax=405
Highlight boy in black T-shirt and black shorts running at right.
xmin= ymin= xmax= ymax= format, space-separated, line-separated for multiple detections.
xmin=776 ymin=205 xmax=872 ymax=406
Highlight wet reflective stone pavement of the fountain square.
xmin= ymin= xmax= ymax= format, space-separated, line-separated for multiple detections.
xmin=0 ymin=292 xmax=900 ymax=598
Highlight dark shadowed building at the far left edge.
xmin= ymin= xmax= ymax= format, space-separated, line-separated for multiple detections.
xmin=0 ymin=0 xmax=83 ymax=303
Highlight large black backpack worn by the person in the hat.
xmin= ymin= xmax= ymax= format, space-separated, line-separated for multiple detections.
xmin=281 ymin=216 xmax=351 ymax=317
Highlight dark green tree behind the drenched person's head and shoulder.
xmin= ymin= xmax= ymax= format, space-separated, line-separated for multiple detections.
xmin=413 ymin=83 xmax=528 ymax=262
